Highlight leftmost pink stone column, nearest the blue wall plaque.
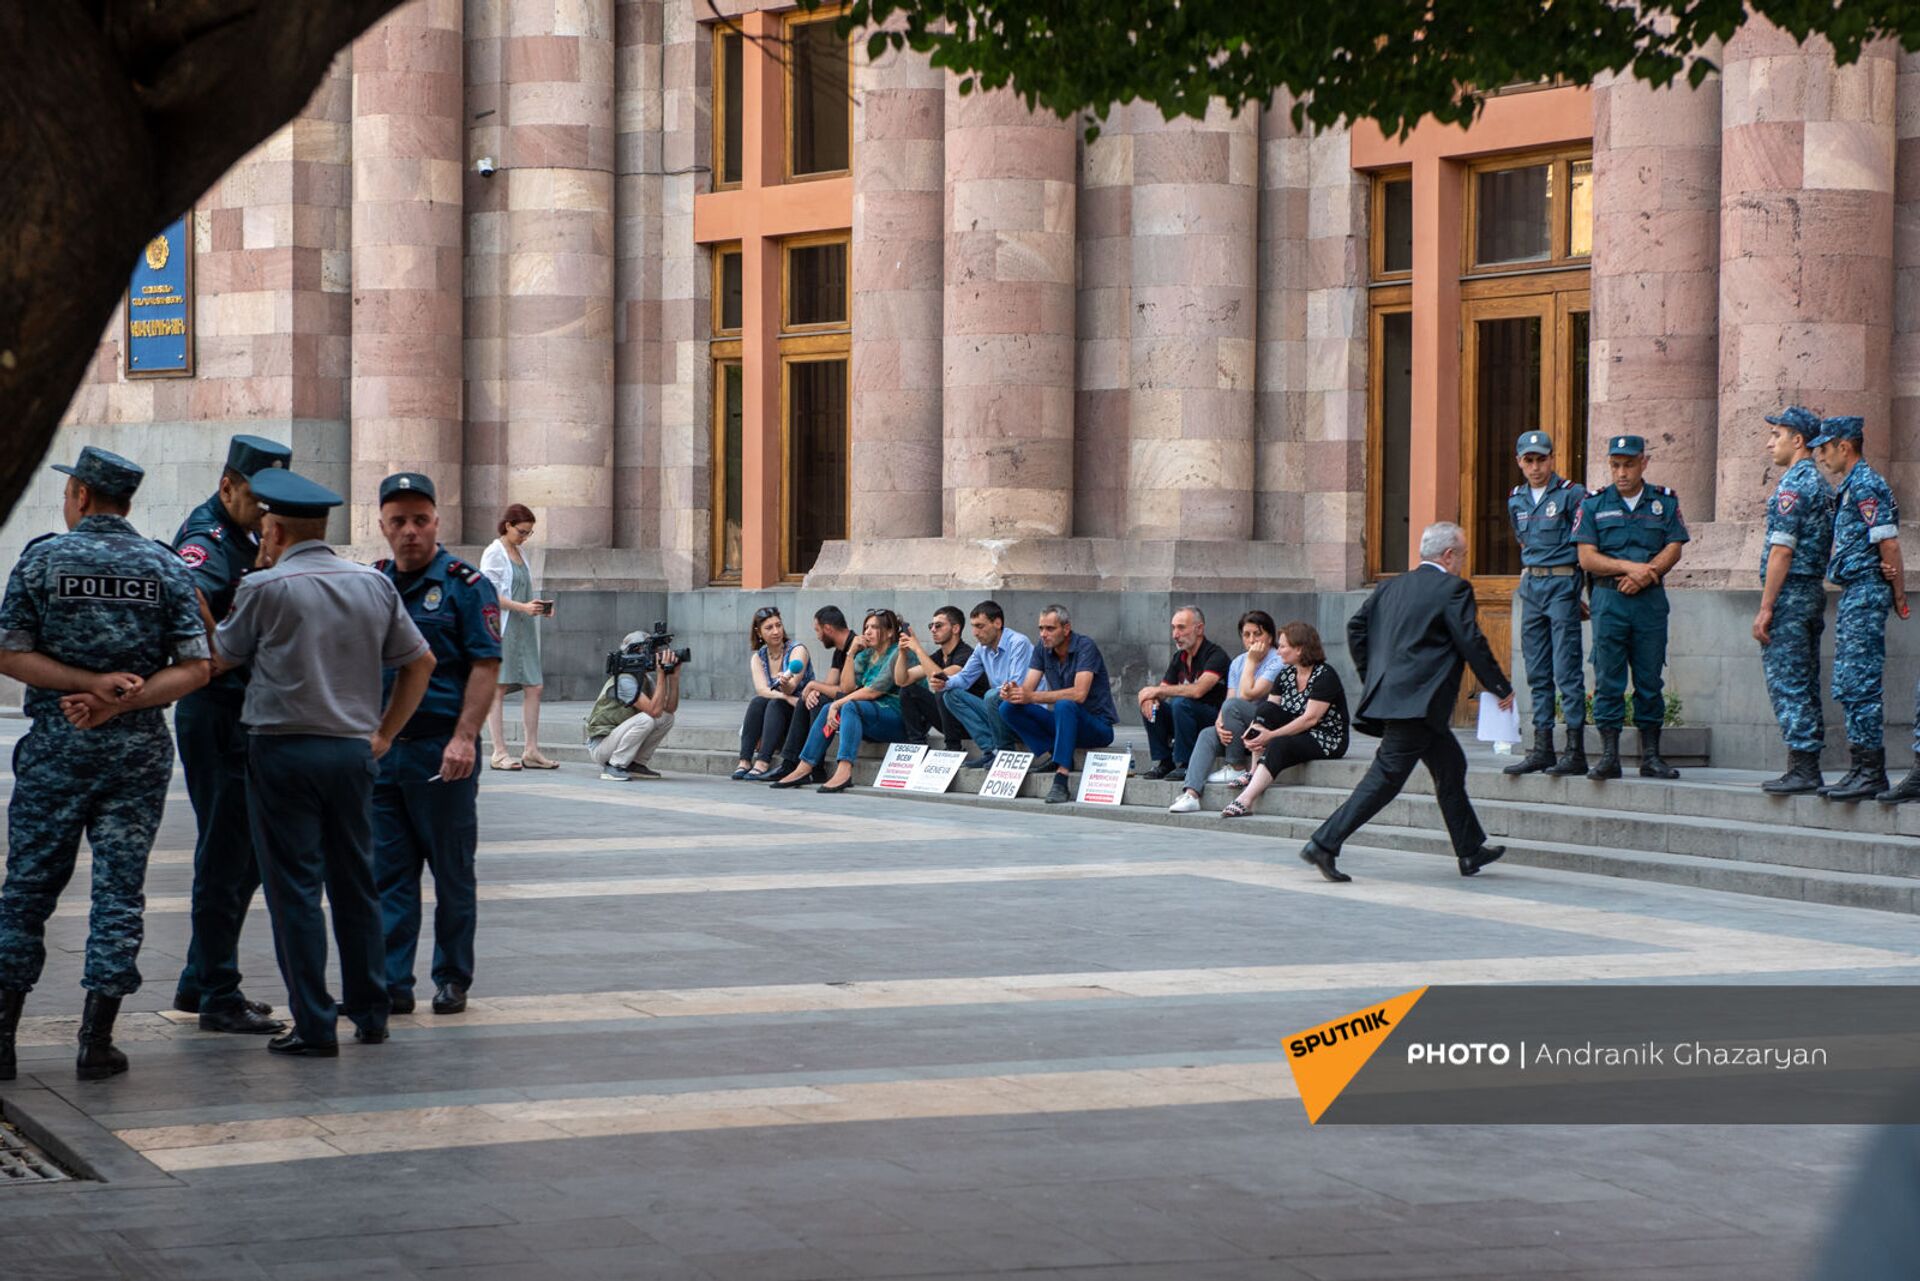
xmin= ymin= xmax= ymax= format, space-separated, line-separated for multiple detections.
xmin=351 ymin=0 xmax=465 ymax=542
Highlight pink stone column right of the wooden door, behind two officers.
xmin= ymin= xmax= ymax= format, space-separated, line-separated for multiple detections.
xmin=1574 ymin=65 xmax=1720 ymax=520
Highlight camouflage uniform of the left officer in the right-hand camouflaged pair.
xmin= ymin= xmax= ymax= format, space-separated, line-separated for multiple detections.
xmin=1761 ymin=459 xmax=1834 ymax=753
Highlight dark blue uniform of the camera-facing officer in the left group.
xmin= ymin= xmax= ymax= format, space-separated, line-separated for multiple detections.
xmin=372 ymin=547 xmax=499 ymax=997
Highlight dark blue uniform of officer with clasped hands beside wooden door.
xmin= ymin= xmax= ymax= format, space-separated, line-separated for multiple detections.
xmin=1572 ymin=484 xmax=1690 ymax=730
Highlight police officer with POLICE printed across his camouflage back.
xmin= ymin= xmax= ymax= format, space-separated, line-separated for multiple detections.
xmin=0 ymin=446 xmax=211 ymax=1081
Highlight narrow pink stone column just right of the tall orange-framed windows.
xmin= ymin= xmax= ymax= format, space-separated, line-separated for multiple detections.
xmin=849 ymin=28 xmax=947 ymax=540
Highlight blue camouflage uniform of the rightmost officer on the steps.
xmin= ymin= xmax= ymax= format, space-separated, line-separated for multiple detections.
xmin=1826 ymin=459 xmax=1901 ymax=751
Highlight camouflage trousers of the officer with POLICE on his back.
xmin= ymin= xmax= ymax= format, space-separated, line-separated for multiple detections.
xmin=0 ymin=711 xmax=173 ymax=997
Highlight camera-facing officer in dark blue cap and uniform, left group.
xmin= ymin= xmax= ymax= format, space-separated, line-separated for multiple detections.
xmin=372 ymin=472 xmax=499 ymax=1014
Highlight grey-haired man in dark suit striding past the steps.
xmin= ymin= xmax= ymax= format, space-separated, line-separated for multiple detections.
xmin=1300 ymin=520 xmax=1513 ymax=882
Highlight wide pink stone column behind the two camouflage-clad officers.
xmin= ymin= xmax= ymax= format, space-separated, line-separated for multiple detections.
xmin=1715 ymin=17 xmax=1895 ymax=520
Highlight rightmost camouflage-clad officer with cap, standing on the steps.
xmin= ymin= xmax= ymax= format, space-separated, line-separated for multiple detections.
xmin=1811 ymin=417 xmax=1907 ymax=801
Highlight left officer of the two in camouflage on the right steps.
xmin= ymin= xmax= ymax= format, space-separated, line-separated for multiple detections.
xmin=1753 ymin=405 xmax=1834 ymax=797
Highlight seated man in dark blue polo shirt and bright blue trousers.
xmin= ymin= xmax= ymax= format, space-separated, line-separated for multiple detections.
xmin=1000 ymin=605 xmax=1119 ymax=805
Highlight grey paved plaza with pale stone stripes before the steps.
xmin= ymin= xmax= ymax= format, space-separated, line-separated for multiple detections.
xmin=0 ymin=720 xmax=1920 ymax=1281
